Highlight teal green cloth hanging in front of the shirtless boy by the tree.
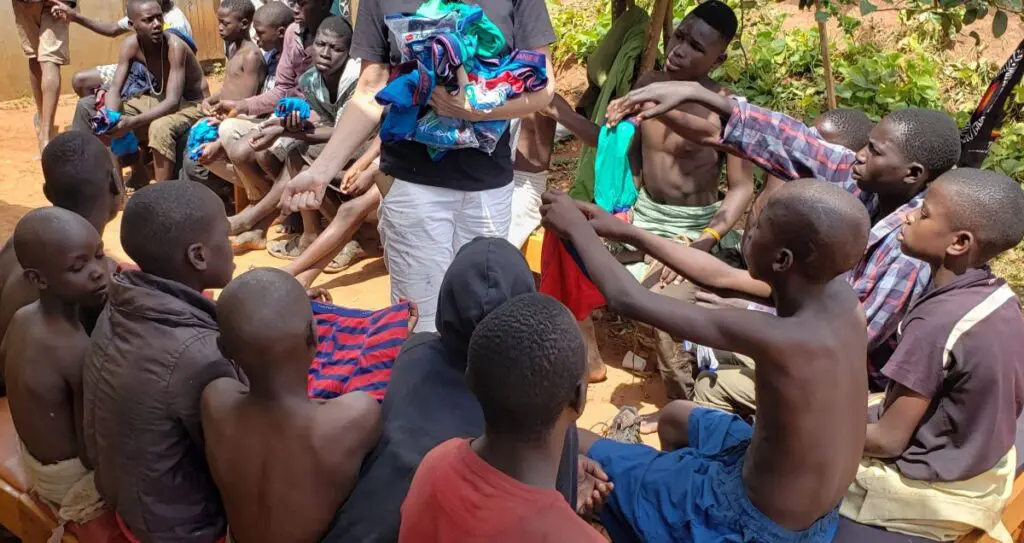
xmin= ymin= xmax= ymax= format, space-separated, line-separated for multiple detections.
xmin=594 ymin=122 xmax=637 ymax=213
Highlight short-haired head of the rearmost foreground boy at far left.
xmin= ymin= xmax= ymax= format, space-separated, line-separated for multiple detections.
xmin=42 ymin=130 xmax=121 ymax=215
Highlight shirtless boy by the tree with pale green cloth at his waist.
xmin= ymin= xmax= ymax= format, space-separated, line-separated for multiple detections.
xmin=546 ymin=0 xmax=754 ymax=259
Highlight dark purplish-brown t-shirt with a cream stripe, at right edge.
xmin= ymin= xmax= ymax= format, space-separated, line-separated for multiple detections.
xmin=882 ymin=268 xmax=1024 ymax=482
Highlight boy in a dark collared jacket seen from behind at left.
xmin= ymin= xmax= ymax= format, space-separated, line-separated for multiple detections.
xmin=83 ymin=181 xmax=240 ymax=542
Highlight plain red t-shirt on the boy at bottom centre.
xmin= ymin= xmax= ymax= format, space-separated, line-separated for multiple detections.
xmin=398 ymin=437 xmax=607 ymax=543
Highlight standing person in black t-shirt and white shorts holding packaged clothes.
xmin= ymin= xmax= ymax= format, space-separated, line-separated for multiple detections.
xmin=281 ymin=0 xmax=555 ymax=332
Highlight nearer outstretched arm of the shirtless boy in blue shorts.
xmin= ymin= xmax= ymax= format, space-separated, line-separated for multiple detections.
xmin=541 ymin=193 xmax=774 ymax=361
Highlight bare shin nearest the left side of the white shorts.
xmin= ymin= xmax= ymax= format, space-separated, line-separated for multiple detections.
xmin=282 ymin=186 xmax=381 ymax=287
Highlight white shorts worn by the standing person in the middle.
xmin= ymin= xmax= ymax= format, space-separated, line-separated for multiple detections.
xmin=377 ymin=179 xmax=513 ymax=332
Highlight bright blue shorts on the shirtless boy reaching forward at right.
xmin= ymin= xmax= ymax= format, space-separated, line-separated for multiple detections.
xmin=587 ymin=408 xmax=839 ymax=543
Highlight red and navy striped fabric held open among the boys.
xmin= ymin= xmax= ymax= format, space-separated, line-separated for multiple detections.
xmin=306 ymin=301 xmax=410 ymax=402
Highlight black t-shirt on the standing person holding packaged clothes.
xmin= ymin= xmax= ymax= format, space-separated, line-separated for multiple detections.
xmin=351 ymin=0 xmax=555 ymax=191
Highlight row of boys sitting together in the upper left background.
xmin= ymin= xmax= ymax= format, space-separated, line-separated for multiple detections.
xmin=62 ymin=0 xmax=372 ymax=286
